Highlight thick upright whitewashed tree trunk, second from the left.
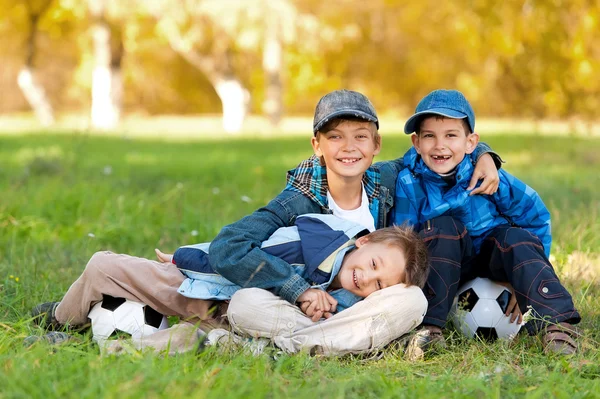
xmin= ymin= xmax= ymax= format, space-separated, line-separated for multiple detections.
xmin=88 ymin=0 xmax=123 ymax=130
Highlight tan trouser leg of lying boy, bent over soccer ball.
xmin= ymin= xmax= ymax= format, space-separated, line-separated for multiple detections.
xmin=56 ymin=251 xmax=226 ymax=329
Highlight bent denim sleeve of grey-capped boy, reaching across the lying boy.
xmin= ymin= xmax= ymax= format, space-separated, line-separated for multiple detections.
xmin=209 ymin=190 xmax=319 ymax=304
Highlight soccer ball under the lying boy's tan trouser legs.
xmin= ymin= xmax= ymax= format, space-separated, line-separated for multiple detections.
xmin=88 ymin=295 xmax=169 ymax=343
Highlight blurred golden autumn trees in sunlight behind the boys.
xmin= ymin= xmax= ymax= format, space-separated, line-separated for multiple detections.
xmin=0 ymin=0 xmax=600 ymax=134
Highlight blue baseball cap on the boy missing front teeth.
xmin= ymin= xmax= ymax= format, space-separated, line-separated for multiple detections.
xmin=404 ymin=90 xmax=475 ymax=134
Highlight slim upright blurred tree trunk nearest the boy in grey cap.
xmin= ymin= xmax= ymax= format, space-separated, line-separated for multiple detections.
xmin=263 ymin=11 xmax=283 ymax=127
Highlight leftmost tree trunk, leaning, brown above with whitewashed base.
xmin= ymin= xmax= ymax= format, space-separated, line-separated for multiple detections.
xmin=17 ymin=0 xmax=54 ymax=126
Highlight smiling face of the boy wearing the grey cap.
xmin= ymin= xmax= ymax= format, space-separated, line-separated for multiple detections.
xmin=311 ymin=121 xmax=380 ymax=179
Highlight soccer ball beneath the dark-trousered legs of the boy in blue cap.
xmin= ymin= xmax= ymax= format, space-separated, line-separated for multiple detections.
xmin=450 ymin=277 xmax=522 ymax=341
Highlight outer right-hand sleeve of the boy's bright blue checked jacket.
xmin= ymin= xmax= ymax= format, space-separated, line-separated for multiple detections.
xmin=494 ymin=170 xmax=552 ymax=256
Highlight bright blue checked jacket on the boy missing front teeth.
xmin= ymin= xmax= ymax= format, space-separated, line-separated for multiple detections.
xmin=392 ymin=147 xmax=552 ymax=256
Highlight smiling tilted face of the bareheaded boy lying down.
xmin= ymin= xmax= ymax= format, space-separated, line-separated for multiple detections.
xmin=332 ymin=236 xmax=406 ymax=298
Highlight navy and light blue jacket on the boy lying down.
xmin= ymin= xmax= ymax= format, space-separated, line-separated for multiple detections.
xmin=173 ymin=214 xmax=369 ymax=311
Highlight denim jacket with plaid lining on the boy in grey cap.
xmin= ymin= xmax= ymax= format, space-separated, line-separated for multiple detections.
xmin=209 ymin=143 xmax=501 ymax=303
